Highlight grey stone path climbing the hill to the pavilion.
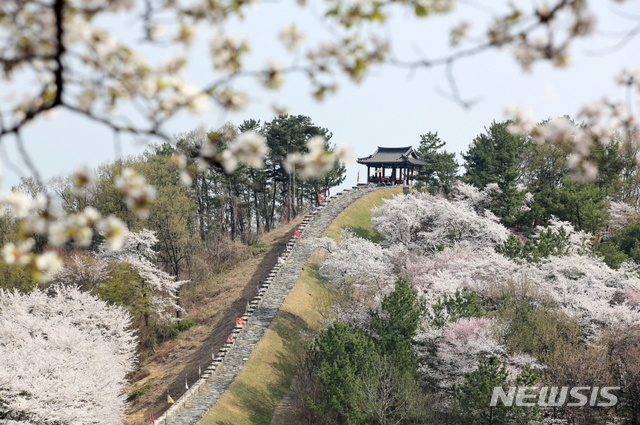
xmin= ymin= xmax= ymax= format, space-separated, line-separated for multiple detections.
xmin=156 ymin=186 xmax=378 ymax=425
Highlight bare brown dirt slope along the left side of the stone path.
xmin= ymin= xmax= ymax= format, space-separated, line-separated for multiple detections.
xmin=126 ymin=217 xmax=302 ymax=425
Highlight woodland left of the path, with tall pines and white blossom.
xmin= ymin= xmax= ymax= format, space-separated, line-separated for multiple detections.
xmin=0 ymin=115 xmax=345 ymax=424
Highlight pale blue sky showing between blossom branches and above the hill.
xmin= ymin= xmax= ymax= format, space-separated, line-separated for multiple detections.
xmin=0 ymin=0 xmax=640 ymax=190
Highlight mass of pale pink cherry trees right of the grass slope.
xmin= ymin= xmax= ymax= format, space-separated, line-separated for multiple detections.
xmin=321 ymin=186 xmax=640 ymax=394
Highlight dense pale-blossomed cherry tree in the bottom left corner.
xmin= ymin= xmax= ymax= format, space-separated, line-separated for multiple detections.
xmin=0 ymin=286 xmax=136 ymax=425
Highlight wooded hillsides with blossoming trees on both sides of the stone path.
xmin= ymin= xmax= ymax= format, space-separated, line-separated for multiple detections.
xmin=0 ymin=115 xmax=640 ymax=424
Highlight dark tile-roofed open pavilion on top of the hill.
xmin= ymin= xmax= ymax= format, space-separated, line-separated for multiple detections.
xmin=357 ymin=146 xmax=427 ymax=185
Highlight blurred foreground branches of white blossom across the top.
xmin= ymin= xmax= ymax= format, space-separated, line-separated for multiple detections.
xmin=0 ymin=0 xmax=638 ymax=148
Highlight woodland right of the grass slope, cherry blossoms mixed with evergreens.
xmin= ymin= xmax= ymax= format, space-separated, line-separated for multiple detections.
xmin=294 ymin=118 xmax=640 ymax=425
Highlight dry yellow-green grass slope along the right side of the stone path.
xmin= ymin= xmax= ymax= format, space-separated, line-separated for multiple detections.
xmin=198 ymin=187 xmax=402 ymax=425
